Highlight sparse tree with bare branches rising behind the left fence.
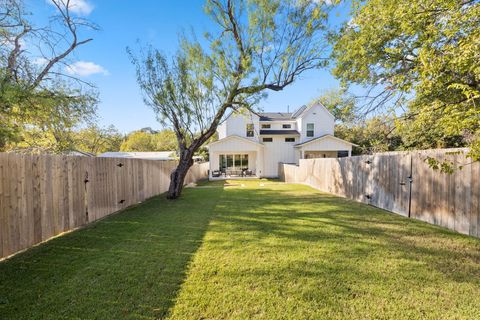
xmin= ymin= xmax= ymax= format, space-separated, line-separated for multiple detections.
xmin=0 ymin=0 xmax=97 ymax=150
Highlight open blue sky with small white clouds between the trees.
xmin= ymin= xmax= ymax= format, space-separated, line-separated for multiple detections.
xmin=31 ymin=0 xmax=347 ymax=133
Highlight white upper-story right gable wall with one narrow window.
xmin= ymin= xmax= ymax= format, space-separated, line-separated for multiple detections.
xmin=298 ymin=105 xmax=335 ymax=142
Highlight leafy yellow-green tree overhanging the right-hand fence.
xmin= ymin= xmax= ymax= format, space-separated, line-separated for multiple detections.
xmin=334 ymin=0 xmax=480 ymax=159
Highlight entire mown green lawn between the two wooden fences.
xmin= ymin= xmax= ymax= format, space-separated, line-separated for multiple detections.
xmin=0 ymin=180 xmax=480 ymax=320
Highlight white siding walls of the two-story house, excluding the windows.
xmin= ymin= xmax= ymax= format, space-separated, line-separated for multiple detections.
xmin=209 ymin=105 xmax=352 ymax=177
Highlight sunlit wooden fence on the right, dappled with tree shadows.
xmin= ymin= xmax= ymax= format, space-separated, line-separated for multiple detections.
xmin=280 ymin=149 xmax=480 ymax=237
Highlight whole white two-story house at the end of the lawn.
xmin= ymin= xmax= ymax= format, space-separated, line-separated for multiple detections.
xmin=208 ymin=104 xmax=353 ymax=178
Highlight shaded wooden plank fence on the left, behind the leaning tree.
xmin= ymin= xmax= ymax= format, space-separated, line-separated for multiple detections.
xmin=0 ymin=153 xmax=208 ymax=258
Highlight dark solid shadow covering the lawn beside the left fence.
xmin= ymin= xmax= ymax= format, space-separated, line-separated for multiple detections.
xmin=0 ymin=188 xmax=224 ymax=319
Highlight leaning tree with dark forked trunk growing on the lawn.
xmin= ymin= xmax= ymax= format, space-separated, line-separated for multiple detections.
xmin=130 ymin=0 xmax=330 ymax=199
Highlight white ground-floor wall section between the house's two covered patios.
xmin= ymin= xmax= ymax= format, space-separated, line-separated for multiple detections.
xmin=262 ymin=135 xmax=298 ymax=177
